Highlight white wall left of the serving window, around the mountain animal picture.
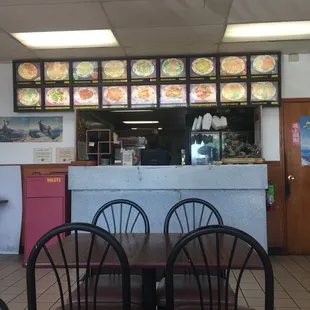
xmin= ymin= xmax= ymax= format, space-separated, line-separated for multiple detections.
xmin=0 ymin=63 xmax=75 ymax=164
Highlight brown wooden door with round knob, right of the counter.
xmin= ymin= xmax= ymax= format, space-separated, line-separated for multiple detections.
xmin=283 ymin=99 xmax=310 ymax=255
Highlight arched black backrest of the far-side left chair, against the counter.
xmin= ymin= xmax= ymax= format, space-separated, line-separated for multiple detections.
xmin=92 ymin=199 xmax=150 ymax=233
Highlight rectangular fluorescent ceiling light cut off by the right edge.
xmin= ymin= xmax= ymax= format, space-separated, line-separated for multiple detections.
xmin=223 ymin=21 xmax=310 ymax=42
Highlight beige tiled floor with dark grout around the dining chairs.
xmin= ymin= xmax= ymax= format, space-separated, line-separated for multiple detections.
xmin=0 ymin=255 xmax=310 ymax=310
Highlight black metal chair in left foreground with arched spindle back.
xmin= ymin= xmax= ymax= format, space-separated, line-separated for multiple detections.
xmin=27 ymin=223 xmax=142 ymax=310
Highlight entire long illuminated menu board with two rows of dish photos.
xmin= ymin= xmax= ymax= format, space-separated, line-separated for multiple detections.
xmin=13 ymin=52 xmax=281 ymax=112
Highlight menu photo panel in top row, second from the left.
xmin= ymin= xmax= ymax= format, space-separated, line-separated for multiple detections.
xmin=44 ymin=61 xmax=69 ymax=84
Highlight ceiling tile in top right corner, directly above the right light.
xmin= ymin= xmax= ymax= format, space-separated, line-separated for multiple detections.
xmin=228 ymin=0 xmax=310 ymax=23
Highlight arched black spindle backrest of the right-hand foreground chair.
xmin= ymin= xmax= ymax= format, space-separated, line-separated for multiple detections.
xmin=165 ymin=225 xmax=274 ymax=310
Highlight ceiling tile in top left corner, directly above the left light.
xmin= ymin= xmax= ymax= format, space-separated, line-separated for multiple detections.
xmin=0 ymin=3 xmax=109 ymax=33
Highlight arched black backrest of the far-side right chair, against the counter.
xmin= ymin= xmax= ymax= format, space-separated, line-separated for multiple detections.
xmin=164 ymin=198 xmax=223 ymax=233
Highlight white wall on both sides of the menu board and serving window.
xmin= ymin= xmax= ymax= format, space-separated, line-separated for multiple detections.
xmin=0 ymin=54 xmax=310 ymax=164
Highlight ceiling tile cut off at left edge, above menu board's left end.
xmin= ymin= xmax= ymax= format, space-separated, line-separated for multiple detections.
xmin=0 ymin=33 xmax=36 ymax=61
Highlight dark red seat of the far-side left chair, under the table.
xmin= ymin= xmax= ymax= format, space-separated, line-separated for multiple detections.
xmin=72 ymin=274 xmax=142 ymax=305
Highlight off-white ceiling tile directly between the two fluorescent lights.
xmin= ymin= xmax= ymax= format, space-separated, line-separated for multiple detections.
xmin=116 ymin=25 xmax=224 ymax=47
